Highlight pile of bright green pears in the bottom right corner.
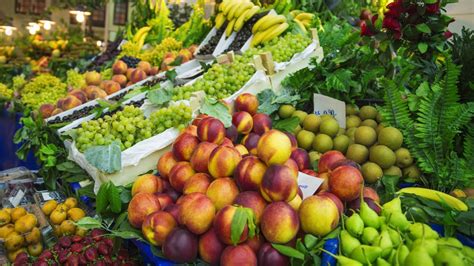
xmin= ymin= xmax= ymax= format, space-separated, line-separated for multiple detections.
xmin=335 ymin=198 xmax=474 ymax=266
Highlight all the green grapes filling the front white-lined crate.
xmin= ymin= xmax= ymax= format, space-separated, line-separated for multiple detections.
xmin=76 ymin=104 xmax=192 ymax=152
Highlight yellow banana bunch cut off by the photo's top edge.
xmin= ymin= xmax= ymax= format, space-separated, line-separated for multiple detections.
xmin=216 ymin=0 xmax=260 ymax=37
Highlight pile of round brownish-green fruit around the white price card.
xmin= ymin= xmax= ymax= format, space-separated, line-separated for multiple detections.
xmin=278 ymin=105 xmax=420 ymax=183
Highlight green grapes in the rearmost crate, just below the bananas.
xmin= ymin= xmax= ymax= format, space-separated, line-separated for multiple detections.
xmin=243 ymin=33 xmax=311 ymax=62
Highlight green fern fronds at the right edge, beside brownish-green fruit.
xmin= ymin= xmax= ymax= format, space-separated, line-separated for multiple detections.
xmin=381 ymin=56 xmax=474 ymax=192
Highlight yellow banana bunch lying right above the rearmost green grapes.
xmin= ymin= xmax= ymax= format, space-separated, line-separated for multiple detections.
xmin=250 ymin=14 xmax=289 ymax=46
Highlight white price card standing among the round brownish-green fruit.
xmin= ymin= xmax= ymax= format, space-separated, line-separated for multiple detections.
xmin=313 ymin=93 xmax=346 ymax=128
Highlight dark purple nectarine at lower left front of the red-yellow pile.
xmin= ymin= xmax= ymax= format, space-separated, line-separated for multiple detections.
xmin=163 ymin=228 xmax=198 ymax=263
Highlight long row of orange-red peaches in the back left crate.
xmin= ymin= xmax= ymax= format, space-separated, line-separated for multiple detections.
xmin=39 ymin=60 xmax=159 ymax=118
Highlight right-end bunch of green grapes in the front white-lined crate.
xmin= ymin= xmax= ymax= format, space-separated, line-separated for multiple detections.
xmin=149 ymin=103 xmax=192 ymax=135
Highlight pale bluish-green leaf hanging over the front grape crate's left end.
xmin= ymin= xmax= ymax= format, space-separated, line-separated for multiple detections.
xmin=84 ymin=142 xmax=122 ymax=174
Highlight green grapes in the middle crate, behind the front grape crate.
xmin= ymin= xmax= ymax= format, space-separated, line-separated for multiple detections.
xmin=172 ymin=55 xmax=255 ymax=101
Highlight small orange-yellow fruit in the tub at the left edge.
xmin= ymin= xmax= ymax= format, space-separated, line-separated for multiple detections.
xmin=0 ymin=207 xmax=43 ymax=261
